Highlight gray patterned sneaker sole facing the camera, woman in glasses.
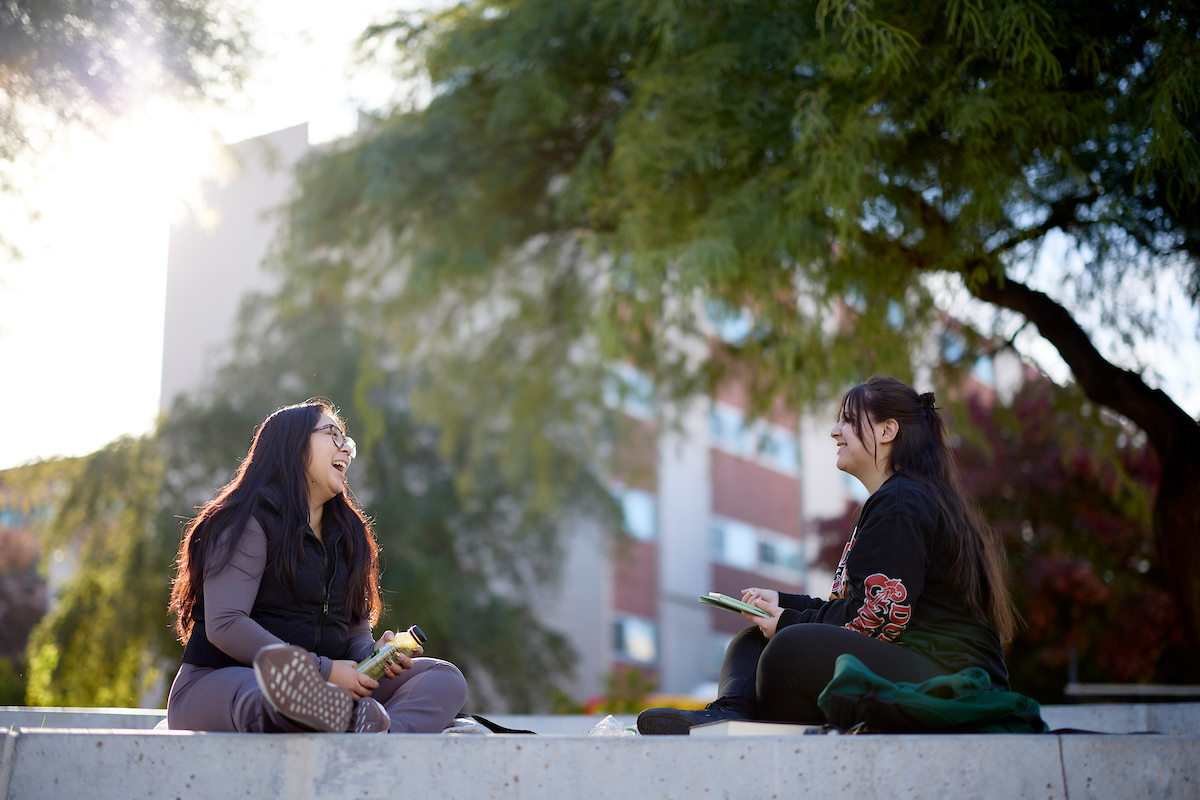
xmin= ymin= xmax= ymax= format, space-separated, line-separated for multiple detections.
xmin=254 ymin=644 xmax=352 ymax=733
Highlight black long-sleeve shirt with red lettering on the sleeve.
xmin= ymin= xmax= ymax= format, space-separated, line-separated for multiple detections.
xmin=779 ymin=474 xmax=1008 ymax=687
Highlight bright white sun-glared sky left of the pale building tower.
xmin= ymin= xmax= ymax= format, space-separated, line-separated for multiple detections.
xmin=0 ymin=0 xmax=413 ymax=469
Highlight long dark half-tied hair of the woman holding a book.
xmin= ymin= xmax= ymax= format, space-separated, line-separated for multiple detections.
xmin=840 ymin=377 xmax=1018 ymax=644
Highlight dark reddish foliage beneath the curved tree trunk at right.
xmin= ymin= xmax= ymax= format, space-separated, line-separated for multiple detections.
xmin=958 ymin=379 xmax=1200 ymax=703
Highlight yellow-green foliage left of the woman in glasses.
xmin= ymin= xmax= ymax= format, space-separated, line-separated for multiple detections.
xmin=28 ymin=438 xmax=179 ymax=706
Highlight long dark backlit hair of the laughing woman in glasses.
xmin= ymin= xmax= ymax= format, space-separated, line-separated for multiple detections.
xmin=170 ymin=399 xmax=383 ymax=642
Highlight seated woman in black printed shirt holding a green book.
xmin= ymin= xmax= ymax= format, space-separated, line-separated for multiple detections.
xmin=637 ymin=378 xmax=1015 ymax=734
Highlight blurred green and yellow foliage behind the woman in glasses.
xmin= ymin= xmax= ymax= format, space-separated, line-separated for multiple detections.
xmin=30 ymin=267 xmax=616 ymax=711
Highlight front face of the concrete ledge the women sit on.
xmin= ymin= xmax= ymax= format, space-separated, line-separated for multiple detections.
xmin=0 ymin=729 xmax=1200 ymax=800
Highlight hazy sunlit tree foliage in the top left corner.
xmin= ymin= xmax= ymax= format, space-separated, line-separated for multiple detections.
xmin=0 ymin=0 xmax=250 ymax=192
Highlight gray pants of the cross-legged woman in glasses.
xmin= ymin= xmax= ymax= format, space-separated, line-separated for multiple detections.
xmin=167 ymin=658 xmax=467 ymax=733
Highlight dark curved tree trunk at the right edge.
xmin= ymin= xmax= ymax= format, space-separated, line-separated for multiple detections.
xmin=968 ymin=278 xmax=1200 ymax=643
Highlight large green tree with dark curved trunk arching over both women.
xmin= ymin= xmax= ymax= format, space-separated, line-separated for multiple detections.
xmin=286 ymin=0 xmax=1200 ymax=639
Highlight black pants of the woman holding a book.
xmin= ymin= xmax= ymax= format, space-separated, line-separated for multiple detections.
xmin=720 ymin=622 xmax=946 ymax=724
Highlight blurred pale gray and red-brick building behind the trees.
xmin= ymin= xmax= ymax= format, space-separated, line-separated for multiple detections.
xmin=152 ymin=125 xmax=955 ymax=700
